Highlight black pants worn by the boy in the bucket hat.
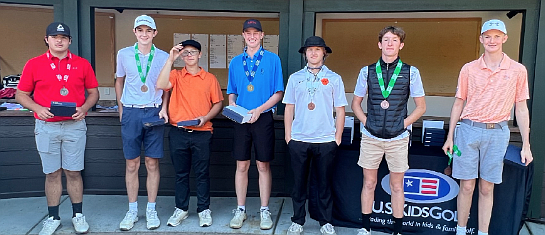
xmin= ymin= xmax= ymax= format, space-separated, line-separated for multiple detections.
xmin=288 ymin=140 xmax=337 ymax=226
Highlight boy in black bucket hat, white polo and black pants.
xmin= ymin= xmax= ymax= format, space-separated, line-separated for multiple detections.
xmin=282 ymin=36 xmax=348 ymax=235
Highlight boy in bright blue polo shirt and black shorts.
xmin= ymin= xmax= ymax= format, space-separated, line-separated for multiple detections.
xmin=227 ymin=19 xmax=284 ymax=229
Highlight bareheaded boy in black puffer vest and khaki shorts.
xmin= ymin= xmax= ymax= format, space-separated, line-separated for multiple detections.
xmin=352 ymin=26 xmax=426 ymax=235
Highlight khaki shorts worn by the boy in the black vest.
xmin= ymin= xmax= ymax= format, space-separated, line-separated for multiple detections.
xmin=358 ymin=135 xmax=409 ymax=172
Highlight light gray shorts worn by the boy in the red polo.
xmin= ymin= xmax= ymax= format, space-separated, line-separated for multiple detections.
xmin=34 ymin=119 xmax=87 ymax=174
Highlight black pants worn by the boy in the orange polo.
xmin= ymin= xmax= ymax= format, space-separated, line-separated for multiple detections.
xmin=169 ymin=127 xmax=212 ymax=212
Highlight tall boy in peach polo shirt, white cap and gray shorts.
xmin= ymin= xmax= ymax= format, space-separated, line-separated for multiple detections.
xmin=443 ymin=20 xmax=533 ymax=235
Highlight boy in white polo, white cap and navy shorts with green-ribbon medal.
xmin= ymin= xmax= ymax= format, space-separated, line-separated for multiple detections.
xmin=115 ymin=15 xmax=168 ymax=231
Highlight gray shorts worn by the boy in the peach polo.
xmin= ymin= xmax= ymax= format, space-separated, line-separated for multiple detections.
xmin=452 ymin=123 xmax=511 ymax=184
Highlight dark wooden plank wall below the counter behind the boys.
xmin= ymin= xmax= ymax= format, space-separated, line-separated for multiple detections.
xmin=0 ymin=116 xmax=291 ymax=198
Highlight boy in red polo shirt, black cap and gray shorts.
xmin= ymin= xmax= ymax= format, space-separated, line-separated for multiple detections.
xmin=15 ymin=22 xmax=99 ymax=235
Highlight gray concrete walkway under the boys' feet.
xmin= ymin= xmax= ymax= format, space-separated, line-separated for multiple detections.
xmin=0 ymin=195 xmax=386 ymax=235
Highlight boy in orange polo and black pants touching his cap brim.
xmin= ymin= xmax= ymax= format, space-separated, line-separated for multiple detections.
xmin=157 ymin=40 xmax=223 ymax=227
